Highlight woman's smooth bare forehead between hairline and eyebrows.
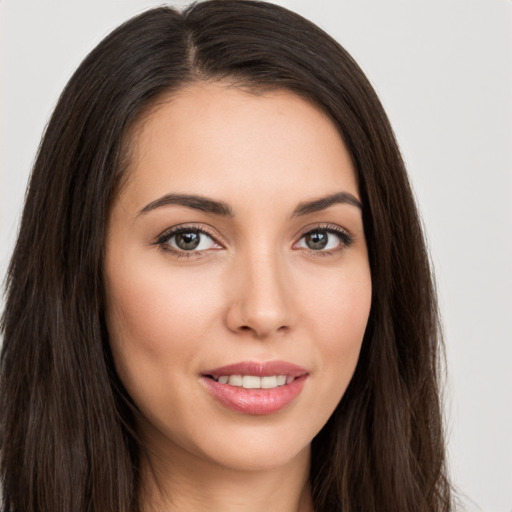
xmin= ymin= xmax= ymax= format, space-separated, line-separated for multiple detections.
xmin=122 ymin=83 xmax=358 ymax=212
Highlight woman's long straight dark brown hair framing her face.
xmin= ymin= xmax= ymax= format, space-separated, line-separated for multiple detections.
xmin=0 ymin=0 xmax=451 ymax=512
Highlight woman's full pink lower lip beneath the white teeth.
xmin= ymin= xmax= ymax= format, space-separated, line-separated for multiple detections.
xmin=201 ymin=375 xmax=308 ymax=415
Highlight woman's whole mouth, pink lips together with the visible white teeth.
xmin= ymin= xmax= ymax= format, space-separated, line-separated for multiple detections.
xmin=201 ymin=361 xmax=308 ymax=415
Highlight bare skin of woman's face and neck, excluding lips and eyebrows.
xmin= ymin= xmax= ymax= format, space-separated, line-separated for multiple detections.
xmin=105 ymin=83 xmax=371 ymax=512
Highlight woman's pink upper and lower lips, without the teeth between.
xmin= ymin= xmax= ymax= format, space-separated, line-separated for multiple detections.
xmin=201 ymin=361 xmax=308 ymax=415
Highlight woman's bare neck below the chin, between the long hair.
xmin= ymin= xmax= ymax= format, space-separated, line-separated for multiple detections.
xmin=140 ymin=440 xmax=313 ymax=512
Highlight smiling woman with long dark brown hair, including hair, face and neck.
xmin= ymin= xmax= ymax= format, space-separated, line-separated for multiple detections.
xmin=0 ymin=0 xmax=450 ymax=512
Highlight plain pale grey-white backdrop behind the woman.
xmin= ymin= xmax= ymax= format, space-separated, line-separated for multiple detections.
xmin=0 ymin=0 xmax=512 ymax=512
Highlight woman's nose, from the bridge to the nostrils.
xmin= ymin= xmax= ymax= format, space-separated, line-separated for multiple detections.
xmin=226 ymin=252 xmax=295 ymax=339
